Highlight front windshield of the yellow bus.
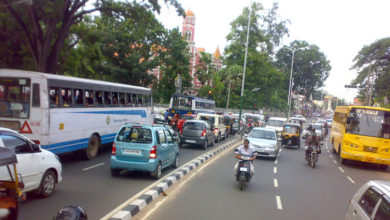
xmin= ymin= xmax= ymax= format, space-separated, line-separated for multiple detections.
xmin=346 ymin=108 xmax=390 ymax=139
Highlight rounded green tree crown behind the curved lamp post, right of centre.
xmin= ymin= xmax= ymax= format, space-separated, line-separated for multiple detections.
xmin=276 ymin=41 xmax=331 ymax=97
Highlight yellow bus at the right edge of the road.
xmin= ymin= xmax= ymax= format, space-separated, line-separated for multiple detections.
xmin=330 ymin=106 xmax=390 ymax=169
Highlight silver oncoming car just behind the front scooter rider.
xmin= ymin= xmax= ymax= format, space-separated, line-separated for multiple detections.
xmin=248 ymin=127 xmax=280 ymax=159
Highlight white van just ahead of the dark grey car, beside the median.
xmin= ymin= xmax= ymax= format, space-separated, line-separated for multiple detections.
xmin=196 ymin=113 xmax=229 ymax=142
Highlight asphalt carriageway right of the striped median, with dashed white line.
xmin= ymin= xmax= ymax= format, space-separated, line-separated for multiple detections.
xmin=142 ymin=137 xmax=390 ymax=220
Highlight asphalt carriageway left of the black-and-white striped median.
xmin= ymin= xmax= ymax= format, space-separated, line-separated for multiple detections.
xmin=19 ymin=135 xmax=236 ymax=220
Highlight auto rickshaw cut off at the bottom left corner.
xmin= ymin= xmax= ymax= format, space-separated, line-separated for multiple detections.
xmin=0 ymin=147 xmax=25 ymax=220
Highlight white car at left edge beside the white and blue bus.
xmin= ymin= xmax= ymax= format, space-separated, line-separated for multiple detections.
xmin=0 ymin=127 xmax=62 ymax=197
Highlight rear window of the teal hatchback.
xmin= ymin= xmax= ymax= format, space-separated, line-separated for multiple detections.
xmin=116 ymin=127 xmax=153 ymax=144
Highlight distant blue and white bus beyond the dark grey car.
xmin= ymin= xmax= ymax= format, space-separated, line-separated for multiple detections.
xmin=169 ymin=94 xmax=215 ymax=117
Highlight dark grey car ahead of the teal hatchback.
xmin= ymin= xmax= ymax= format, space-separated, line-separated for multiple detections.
xmin=179 ymin=120 xmax=214 ymax=150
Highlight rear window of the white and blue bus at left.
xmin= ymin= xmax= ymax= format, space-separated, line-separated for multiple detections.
xmin=0 ymin=78 xmax=31 ymax=118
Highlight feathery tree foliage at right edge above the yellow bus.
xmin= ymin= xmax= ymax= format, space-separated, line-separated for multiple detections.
xmin=351 ymin=37 xmax=390 ymax=104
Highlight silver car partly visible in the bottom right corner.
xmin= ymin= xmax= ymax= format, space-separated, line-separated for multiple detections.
xmin=346 ymin=180 xmax=390 ymax=220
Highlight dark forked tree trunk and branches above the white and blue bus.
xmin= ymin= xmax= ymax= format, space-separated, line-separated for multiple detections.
xmin=0 ymin=0 xmax=184 ymax=73
